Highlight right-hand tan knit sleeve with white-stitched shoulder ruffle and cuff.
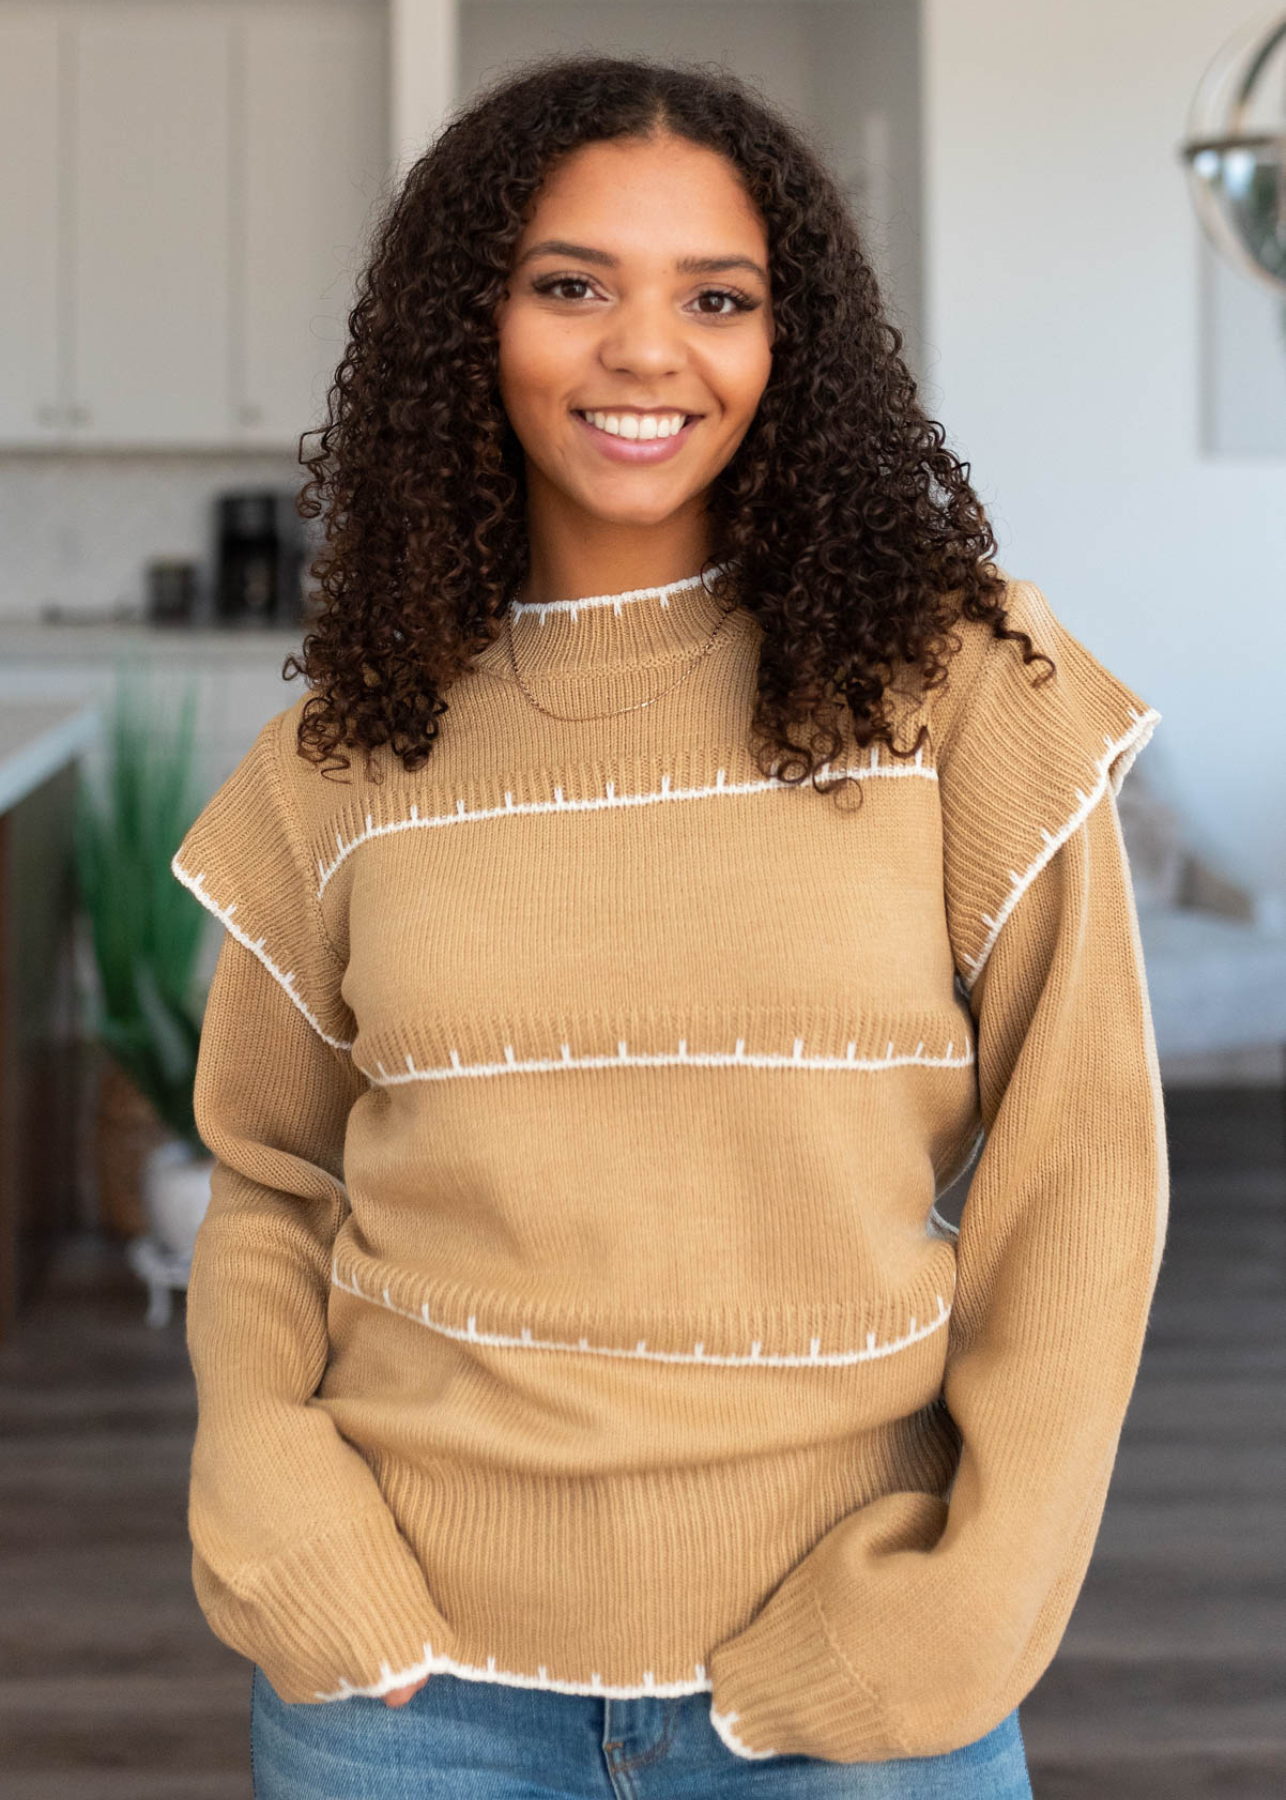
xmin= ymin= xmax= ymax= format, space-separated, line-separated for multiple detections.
xmin=711 ymin=590 xmax=1169 ymax=1762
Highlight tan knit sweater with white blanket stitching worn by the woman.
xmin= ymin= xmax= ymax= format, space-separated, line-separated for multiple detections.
xmin=175 ymin=571 xmax=1169 ymax=1762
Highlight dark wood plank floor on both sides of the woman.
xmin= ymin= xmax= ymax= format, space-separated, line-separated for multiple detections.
xmin=0 ymin=1089 xmax=1286 ymax=1800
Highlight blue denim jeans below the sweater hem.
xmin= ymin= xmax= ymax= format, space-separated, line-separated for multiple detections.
xmin=250 ymin=1665 xmax=1032 ymax=1800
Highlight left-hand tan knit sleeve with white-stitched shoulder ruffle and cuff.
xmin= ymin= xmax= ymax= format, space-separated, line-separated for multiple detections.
xmin=177 ymin=712 xmax=450 ymax=1701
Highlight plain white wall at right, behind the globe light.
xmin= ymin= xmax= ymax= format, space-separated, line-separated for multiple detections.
xmin=922 ymin=0 xmax=1286 ymax=893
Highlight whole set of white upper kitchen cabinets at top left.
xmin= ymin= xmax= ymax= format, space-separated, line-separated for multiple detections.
xmin=0 ymin=0 xmax=389 ymax=450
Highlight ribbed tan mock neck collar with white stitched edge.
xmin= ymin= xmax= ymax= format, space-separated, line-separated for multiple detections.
xmin=474 ymin=563 xmax=731 ymax=680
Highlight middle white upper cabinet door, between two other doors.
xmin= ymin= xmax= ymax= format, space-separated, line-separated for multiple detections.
xmin=70 ymin=4 xmax=232 ymax=445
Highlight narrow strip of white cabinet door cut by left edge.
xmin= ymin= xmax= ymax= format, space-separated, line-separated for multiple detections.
xmin=0 ymin=5 xmax=67 ymax=445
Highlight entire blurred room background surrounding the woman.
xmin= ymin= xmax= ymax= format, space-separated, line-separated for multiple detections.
xmin=0 ymin=0 xmax=1286 ymax=1800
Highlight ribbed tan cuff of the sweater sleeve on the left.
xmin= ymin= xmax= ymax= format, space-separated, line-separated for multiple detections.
xmin=193 ymin=1505 xmax=454 ymax=1703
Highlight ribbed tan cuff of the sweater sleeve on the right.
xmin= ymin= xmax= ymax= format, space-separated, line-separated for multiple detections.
xmin=710 ymin=1568 xmax=908 ymax=1762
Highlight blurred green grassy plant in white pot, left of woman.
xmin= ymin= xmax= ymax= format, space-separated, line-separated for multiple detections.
xmin=76 ymin=671 xmax=211 ymax=1262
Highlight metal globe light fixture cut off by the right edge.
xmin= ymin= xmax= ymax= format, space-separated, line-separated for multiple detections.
xmin=1180 ymin=13 xmax=1286 ymax=295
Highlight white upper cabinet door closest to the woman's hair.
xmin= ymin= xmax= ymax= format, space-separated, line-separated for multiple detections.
xmin=234 ymin=0 xmax=389 ymax=448
